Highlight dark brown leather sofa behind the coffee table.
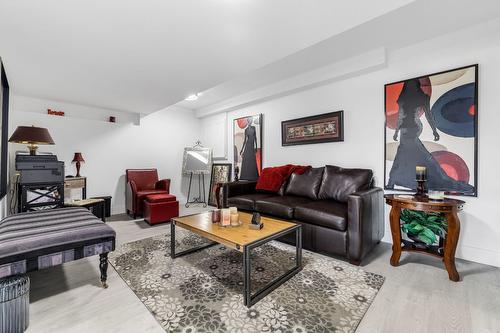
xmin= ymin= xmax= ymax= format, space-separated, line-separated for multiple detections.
xmin=222 ymin=165 xmax=384 ymax=265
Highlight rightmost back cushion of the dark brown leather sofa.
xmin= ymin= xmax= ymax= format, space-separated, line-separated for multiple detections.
xmin=318 ymin=165 xmax=373 ymax=202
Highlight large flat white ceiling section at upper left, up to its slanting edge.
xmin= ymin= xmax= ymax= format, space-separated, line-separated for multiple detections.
xmin=0 ymin=0 xmax=414 ymax=113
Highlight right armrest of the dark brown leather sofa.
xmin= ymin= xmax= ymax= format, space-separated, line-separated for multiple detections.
xmin=347 ymin=187 xmax=385 ymax=265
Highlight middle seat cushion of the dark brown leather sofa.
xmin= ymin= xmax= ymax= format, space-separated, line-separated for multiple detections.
xmin=255 ymin=195 xmax=311 ymax=219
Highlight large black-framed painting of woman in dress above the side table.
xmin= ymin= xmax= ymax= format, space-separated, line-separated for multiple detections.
xmin=385 ymin=64 xmax=478 ymax=196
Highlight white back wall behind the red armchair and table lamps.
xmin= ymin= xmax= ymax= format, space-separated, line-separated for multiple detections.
xmin=9 ymin=96 xmax=200 ymax=214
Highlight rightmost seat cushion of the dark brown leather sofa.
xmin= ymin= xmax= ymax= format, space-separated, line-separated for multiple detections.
xmin=294 ymin=200 xmax=347 ymax=231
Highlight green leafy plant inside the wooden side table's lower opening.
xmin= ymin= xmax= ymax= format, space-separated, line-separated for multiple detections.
xmin=401 ymin=209 xmax=448 ymax=246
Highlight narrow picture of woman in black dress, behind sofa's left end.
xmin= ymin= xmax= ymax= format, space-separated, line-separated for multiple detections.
xmin=233 ymin=114 xmax=262 ymax=180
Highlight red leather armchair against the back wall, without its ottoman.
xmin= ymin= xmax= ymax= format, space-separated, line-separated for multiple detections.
xmin=125 ymin=169 xmax=170 ymax=218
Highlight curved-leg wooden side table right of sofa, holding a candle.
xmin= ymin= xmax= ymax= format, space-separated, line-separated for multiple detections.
xmin=385 ymin=194 xmax=465 ymax=282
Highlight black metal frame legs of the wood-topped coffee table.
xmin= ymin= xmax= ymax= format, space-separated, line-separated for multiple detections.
xmin=170 ymin=220 xmax=302 ymax=307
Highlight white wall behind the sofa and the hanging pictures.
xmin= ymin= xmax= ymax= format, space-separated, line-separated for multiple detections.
xmin=201 ymin=21 xmax=500 ymax=266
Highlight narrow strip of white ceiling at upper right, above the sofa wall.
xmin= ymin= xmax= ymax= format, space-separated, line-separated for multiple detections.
xmin=182 ymin=0 xmax=500 ymax=117
